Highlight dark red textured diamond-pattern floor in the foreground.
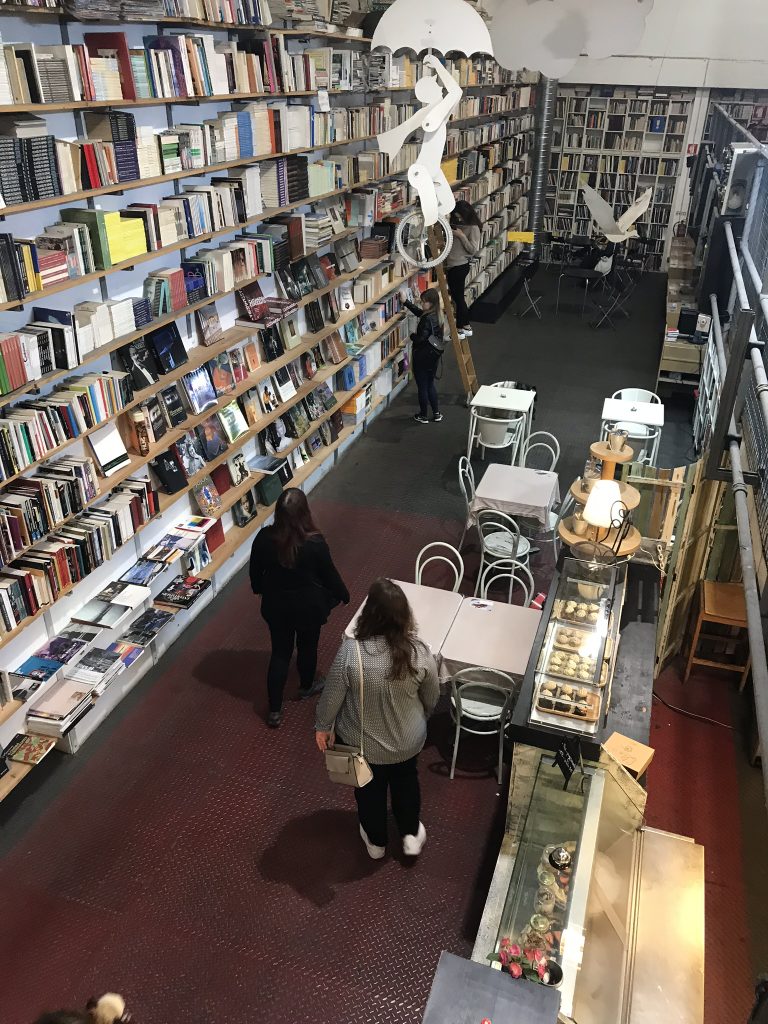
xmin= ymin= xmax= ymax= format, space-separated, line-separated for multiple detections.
xmin=0 ymin=503 xmax=751 ymax=1024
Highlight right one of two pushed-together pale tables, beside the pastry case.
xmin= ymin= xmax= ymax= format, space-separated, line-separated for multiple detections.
xmin=441 ymin=597 xmax=542 ymax=679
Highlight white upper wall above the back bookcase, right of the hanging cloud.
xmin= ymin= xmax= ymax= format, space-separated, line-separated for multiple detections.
xmin=563 ymin=0 xmax=768 ymax=89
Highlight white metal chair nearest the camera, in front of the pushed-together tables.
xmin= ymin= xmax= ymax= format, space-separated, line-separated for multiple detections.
xmin=451 ymin=668 xmax=518 ymax=782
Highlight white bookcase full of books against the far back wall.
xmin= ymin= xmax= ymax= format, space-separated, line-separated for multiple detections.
xmin=545 ymin=85 xmax=694 ymax=270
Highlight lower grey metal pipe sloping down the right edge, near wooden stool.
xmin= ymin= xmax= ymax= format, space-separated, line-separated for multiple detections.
xmin=729 ymin=440 xmax=768 ymax=807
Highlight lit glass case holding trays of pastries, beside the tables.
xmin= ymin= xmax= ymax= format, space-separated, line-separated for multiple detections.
xmin=528 ymin=558 xmax=624 ymax=735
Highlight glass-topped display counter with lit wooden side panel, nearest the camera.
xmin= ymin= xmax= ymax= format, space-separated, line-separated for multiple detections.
xmin=472 ymin=744 xmax=703 ymax=1024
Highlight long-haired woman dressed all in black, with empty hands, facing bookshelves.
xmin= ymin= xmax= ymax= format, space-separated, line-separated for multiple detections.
xmin=250 ymin=487 xmax=349 ymax=729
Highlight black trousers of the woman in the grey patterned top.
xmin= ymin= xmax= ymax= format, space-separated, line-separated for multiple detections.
xmin=354 ymin=755 xmax=421 ymax=846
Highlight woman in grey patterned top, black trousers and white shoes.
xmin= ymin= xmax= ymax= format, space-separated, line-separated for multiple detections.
xmin=315 ymin=579 xmax=439 ymax=860
